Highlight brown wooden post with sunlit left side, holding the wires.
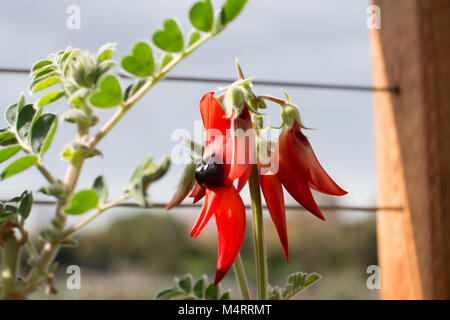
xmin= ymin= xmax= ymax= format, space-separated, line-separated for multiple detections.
xmin=371 ymin=0 xmax=450 ymax=299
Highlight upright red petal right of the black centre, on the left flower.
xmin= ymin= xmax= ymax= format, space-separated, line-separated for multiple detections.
xmin=227 ymin=107 xmax=256 ymax=180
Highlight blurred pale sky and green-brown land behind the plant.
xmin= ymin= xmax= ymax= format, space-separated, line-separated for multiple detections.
xmin=0 ymin=0 xmax=378 ymax=299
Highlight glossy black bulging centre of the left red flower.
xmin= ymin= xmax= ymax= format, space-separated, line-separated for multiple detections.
xmin=195 ymin=155 xmax=225 ymax=188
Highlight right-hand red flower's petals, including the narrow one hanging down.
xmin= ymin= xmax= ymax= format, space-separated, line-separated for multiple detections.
xmin=255 ymin=112 xmax=347 ymax=261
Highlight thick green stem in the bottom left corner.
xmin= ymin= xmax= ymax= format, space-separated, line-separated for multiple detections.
xmin=1 ymin=232 xmax=20 ymax=299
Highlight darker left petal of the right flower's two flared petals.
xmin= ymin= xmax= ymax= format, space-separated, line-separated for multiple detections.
xmin=278 ymin=130 xmax=325 ymax=220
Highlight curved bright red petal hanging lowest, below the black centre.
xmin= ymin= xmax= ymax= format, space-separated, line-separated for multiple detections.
xmin=214 ymin=186 xmax=245 ymax=285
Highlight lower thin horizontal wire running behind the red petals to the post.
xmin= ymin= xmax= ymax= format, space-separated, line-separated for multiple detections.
xmin=0 ymin=200 xmax=403 ymax=212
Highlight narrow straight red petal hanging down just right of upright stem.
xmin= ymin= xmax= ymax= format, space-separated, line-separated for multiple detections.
xmin=260 ymin=174 xmax=289 ymax=262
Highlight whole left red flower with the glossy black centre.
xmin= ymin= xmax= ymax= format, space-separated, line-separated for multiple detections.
xmin=171 ymin=92 xmax=254 ymax=284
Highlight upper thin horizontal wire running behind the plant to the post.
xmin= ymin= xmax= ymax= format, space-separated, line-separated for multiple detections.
xmin=0 ymin=68 xmax=400 ymax=94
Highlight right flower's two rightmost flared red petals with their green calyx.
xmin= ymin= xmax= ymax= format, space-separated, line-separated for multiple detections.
xmin=277 ymin=105 xmax=347 ymax=220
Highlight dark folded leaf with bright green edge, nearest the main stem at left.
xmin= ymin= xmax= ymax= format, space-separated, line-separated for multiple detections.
xmin=30 ymin=113 xmax=58 ymax=157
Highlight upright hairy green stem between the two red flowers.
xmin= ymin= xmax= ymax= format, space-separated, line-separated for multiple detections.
xmin=249 ymin=164 xmax=267 ymax=300
